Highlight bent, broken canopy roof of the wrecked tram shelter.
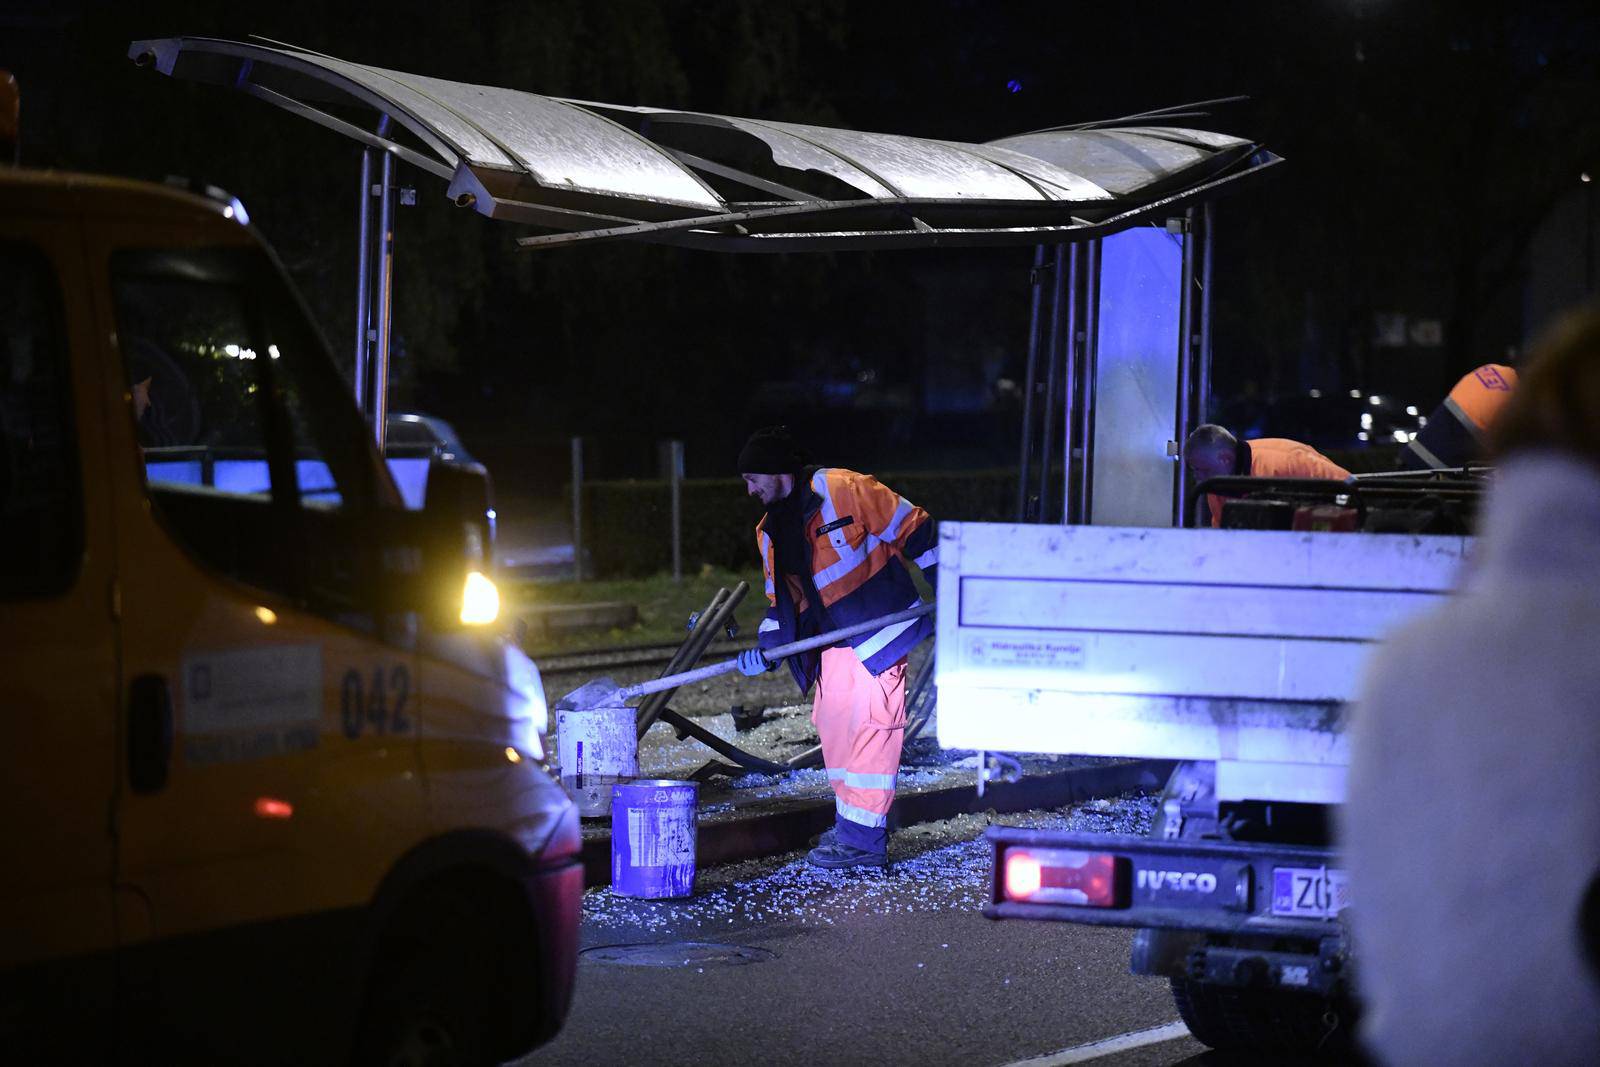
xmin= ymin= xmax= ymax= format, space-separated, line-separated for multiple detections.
xmin=128 ymin=37 xmax=1277 ymax=251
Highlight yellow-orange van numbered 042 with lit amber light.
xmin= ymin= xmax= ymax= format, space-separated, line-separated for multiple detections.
xmin=0 ymin=168 xmax=582 ymax=1064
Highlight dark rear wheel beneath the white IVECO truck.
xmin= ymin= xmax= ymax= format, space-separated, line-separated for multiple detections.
xmin=1171 ymin=977 xmax=1357 ymax=1059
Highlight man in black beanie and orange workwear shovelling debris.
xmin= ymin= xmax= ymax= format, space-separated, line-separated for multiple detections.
xmin=739 ymin=427 xmax=938 ymax=869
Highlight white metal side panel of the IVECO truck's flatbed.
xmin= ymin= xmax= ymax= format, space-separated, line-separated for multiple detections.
xmin=936 ymin=523 xmax=1469 ymax=803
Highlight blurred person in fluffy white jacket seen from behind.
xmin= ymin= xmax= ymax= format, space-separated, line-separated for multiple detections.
xmin=1342 ymin=307 xmax=1600 ymax=1067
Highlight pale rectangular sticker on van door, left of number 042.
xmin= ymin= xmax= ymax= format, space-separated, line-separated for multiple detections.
xmin=181 ymin=645 xmax=322 ymax=765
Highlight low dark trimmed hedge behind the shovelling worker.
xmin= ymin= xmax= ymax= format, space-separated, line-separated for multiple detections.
xmin=582 ymin=470 xmax=1016 ymax=577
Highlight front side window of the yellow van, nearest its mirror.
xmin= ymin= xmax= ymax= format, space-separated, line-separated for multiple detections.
xmin=110 ymin=248 xmax=398 ymax=607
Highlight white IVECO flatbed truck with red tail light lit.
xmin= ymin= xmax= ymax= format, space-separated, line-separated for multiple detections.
xmin=936 ymin=523 xmax=1470 ymax=1053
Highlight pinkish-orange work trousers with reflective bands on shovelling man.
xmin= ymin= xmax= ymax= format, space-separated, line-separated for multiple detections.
xmin=811 ymin=648 xmax=906 ymax=835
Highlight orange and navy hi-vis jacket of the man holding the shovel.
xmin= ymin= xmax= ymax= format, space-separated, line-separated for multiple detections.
xmin=755 ymin=467 xmax=939 ymax=691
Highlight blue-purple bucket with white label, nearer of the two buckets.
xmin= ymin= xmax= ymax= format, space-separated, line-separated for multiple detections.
xmin=611 ymin=779 xmax=699 ymax=899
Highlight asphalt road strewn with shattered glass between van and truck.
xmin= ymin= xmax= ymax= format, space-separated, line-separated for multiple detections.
xmin=522 ymin=798 xmax=1222 ymax=1067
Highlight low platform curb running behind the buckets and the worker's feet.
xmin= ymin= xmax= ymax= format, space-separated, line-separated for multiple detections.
xmin=582 ymin=760 xmax=1176 ymax=889
